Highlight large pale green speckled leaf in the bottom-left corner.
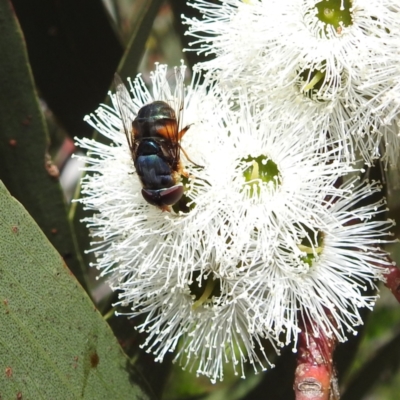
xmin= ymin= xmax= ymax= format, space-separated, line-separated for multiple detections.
xmin=0 ymin=183 xmax=149 ymax=400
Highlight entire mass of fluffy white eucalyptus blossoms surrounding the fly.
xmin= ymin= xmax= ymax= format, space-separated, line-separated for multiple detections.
xmin=77 ymin=0 xmax=400 ymax=381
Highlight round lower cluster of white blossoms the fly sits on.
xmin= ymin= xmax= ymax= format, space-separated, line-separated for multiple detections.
xmin=77 ymin=65 xmax=387 ymax=381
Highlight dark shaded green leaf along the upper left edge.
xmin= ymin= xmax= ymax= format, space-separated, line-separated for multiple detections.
xmin=0 ymin=0 xmax=85 ymax=285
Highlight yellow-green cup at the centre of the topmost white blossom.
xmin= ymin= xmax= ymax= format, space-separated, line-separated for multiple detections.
xmin=315 ymin=0 xmax=353 ymax=30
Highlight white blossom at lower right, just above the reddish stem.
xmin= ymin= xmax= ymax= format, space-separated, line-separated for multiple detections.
xmin=249 ymin=179 xmax=395 ymax=349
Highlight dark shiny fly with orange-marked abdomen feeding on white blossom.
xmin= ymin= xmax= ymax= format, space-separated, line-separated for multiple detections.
xmin=114 ymin=74 xmax=190 ymax=211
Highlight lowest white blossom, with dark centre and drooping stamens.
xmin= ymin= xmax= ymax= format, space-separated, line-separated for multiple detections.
xmin=112 ymin=255 xmax=273 ymax=382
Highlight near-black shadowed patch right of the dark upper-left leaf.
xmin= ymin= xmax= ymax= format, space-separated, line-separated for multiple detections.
xmin=12 ymin=0 xmax=124 ymax=137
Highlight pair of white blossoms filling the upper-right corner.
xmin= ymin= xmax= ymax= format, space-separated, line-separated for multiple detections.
xmin=185 ymin=0 xmax=400 ymax=164
